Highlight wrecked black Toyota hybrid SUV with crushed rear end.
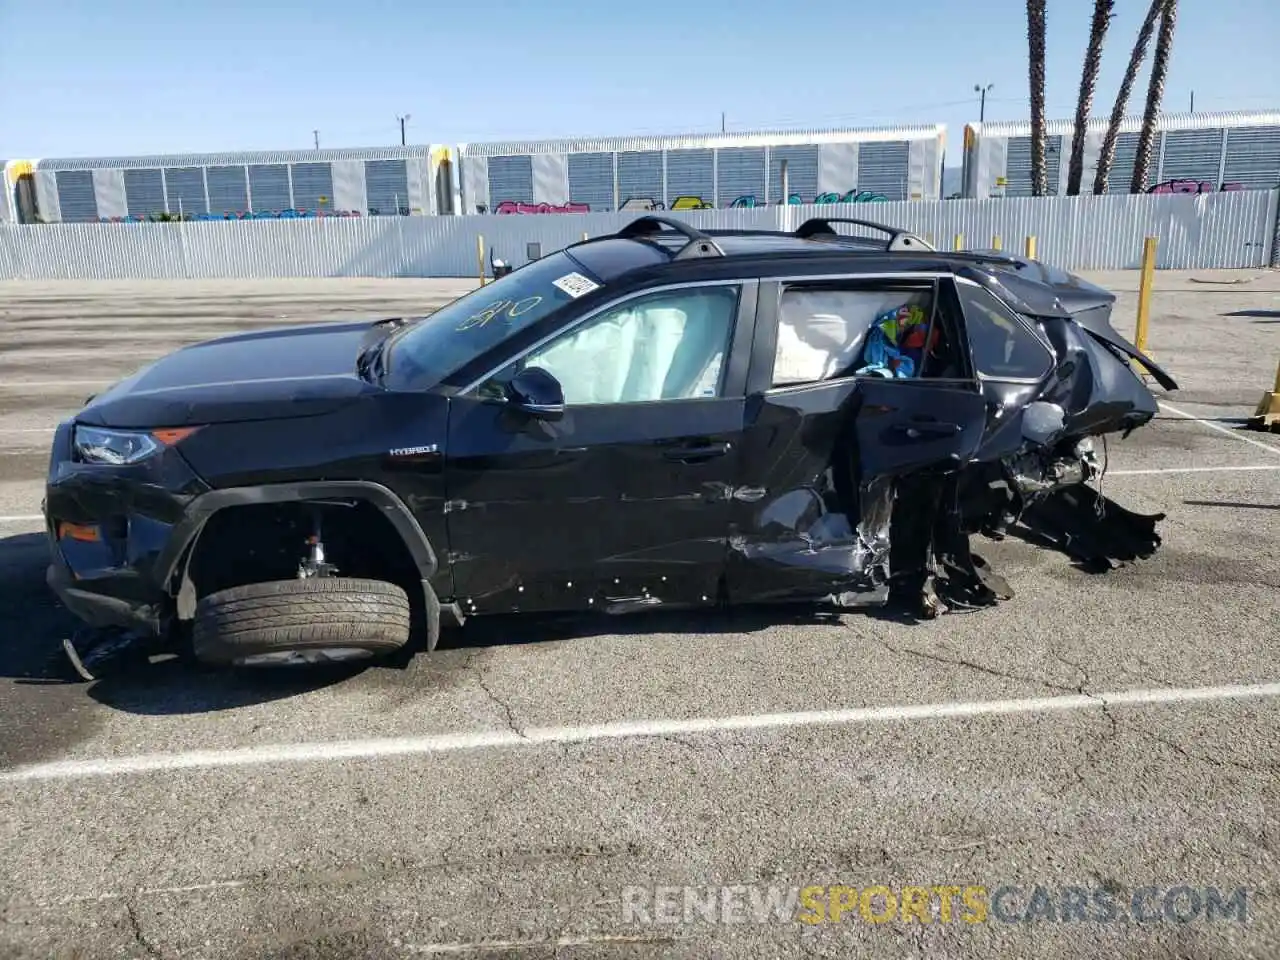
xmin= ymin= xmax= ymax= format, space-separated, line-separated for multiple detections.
xmin=45 ymin=216 xmax=1176 ymax=664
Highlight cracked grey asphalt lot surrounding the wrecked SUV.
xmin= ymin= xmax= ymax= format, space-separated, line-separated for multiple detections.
xmin=0 ymin=271 xmax=1280 ymax=960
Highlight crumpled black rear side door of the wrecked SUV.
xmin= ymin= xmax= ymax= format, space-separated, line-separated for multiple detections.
xmin=728 ymin=279 xmax=986 ymax=603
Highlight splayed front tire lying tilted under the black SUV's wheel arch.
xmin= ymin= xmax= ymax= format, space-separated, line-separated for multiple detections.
xmin=192 ymin=577 xmax=410 ymax=667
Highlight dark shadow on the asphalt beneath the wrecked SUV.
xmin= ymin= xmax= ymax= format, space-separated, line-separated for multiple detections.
xmin=0 ymin=522 xmax=860 ymax=716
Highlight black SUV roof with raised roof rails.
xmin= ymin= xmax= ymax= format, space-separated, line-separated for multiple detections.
xmin=567 ymin=216 xmax=1115 ymax=316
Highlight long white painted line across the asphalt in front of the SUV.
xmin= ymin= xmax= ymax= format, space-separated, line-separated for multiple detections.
xmin=0 ymin=682 xmax=1280 ymax=783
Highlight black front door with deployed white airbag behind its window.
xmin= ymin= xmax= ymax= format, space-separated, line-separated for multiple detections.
xmin=445 ymin=283 xmax=754 ymax=613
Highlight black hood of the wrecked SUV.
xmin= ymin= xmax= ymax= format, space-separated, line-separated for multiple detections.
xmin=76 ymin=321 xmax=387 ymax=428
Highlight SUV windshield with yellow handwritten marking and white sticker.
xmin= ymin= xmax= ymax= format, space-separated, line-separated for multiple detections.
xmin=390 ymin=252 xmax=600 ymax=383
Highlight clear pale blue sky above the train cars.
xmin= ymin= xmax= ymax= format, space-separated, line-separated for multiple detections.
xmin=0 ymin=0 xmax=1280 ymax=165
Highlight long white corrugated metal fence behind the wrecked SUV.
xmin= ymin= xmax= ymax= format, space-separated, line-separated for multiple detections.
xmin=0 ymin=191 xmax=1280 ymax=279
